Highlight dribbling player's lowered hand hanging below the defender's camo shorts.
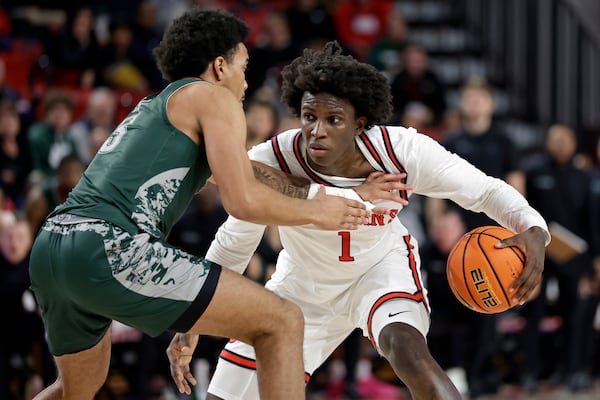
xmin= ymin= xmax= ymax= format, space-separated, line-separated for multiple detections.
xmin=167 ymin=333 xmax=198 ymax=395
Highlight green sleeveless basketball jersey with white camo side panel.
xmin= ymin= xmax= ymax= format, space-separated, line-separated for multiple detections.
xmin=51 ymin=79 xmax=211 ymax=238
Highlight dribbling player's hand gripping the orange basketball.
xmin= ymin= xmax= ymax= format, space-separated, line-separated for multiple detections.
xmin=496 ymin=226 xmax=546 ymax=304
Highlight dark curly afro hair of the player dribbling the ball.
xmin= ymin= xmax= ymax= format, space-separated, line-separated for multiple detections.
xmin=281 ymin=41 xmax=392 ymax=128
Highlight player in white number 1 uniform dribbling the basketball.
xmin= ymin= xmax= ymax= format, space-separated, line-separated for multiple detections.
xmin=166 ymin=42 xmax=550 ymax=400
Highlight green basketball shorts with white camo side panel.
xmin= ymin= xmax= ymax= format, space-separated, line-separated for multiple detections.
xmin=29 ymin=214 xmax=221 ymax=355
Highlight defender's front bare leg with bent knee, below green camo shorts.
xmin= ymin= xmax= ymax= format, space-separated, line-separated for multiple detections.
xmin=189 ymin=268 xmax=305 ymax=400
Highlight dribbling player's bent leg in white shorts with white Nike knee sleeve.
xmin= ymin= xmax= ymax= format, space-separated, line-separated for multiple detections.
xmin=354 ymin=241 xmax=461 ymax=400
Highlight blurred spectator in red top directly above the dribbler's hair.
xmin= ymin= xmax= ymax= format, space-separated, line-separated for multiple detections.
xmin=332 ymin=0 xmax=394 ymax=60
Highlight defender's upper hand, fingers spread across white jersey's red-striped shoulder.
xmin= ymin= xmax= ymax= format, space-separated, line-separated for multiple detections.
xmin=354 ymin=171 xmax=412 ymax=206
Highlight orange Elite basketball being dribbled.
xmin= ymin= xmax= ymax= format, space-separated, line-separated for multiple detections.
xmin=446 ymin=226 xmax=525 ymax=314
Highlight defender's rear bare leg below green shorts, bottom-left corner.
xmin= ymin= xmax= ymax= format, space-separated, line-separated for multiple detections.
xmin=34 ymin=329 xmax=111 ymax=400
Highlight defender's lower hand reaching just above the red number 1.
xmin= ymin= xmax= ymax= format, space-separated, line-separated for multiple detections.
xmin=310 ymin=186 xmax=371 ymax=231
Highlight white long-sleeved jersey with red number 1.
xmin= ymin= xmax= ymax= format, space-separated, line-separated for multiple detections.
xmin=206 ymin=126 xmax=546 ymax=286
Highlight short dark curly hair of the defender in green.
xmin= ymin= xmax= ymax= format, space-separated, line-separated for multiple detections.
xmin=153 ymin=8 xmax=249 ymax=82
